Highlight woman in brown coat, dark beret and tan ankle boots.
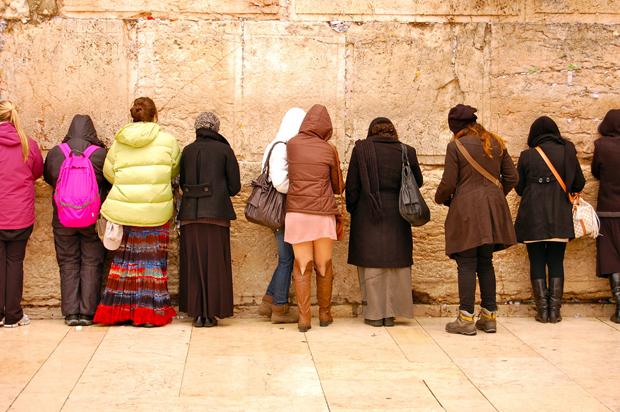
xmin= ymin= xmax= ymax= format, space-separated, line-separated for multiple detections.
xmin=435 ymin=104 xmax=518 ymax=335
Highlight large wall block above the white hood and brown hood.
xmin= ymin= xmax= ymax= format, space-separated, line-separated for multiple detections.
xmin=235 ymin=22 xmax=345 ymax=161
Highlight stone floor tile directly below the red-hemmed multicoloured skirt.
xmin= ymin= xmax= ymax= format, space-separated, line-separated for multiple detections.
xmin=66 ymin=322 xmax=191 ymax=407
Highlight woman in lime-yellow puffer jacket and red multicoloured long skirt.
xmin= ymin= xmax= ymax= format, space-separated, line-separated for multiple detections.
xmin=94 ymin=97 xmax=181 ymax=327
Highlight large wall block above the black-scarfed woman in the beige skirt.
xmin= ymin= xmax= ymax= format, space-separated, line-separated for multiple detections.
xmin=346 ymin=23 xmax=489 ymax=158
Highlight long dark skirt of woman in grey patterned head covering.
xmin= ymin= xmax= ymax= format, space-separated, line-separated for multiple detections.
xmin=179 ymin=223 xmax=233 ymax=318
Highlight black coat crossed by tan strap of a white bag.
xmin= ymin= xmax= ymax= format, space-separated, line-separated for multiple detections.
xmin=515 ymin=140 xmax=586 ymax=242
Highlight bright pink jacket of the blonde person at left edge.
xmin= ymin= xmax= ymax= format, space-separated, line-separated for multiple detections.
xmin=0 ymin=122 xmax=43 ymax=230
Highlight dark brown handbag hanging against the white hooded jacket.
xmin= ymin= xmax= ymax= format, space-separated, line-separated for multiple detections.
xmin=245 ymin=142 xmax=286 ymax=230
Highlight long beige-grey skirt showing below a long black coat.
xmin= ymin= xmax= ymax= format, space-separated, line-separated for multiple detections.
xmin=357 ymin=266 xmax=413 ymax=320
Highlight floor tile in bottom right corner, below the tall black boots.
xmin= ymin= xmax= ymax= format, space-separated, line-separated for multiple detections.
xmin=503 ymin=318 xmax=620 ymax=411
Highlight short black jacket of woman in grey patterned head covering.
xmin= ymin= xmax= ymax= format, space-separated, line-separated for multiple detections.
xmin=179 ymin=129 xmax=241 ymax=221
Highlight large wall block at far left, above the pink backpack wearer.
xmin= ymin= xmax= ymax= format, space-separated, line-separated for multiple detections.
xmin=0 ymin=19 xmax=129 ymax=148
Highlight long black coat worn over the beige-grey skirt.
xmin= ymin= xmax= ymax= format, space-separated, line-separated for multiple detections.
xmin=346 ymin=138 xmax=423 ymax=268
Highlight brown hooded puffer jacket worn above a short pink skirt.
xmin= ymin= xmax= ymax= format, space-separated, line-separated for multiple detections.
xmin=286 ymin=104 xmax=344 ymax=215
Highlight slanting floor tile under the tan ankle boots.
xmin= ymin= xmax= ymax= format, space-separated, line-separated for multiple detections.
xmin=418 ymin=319 xmax=606 ymax=411
